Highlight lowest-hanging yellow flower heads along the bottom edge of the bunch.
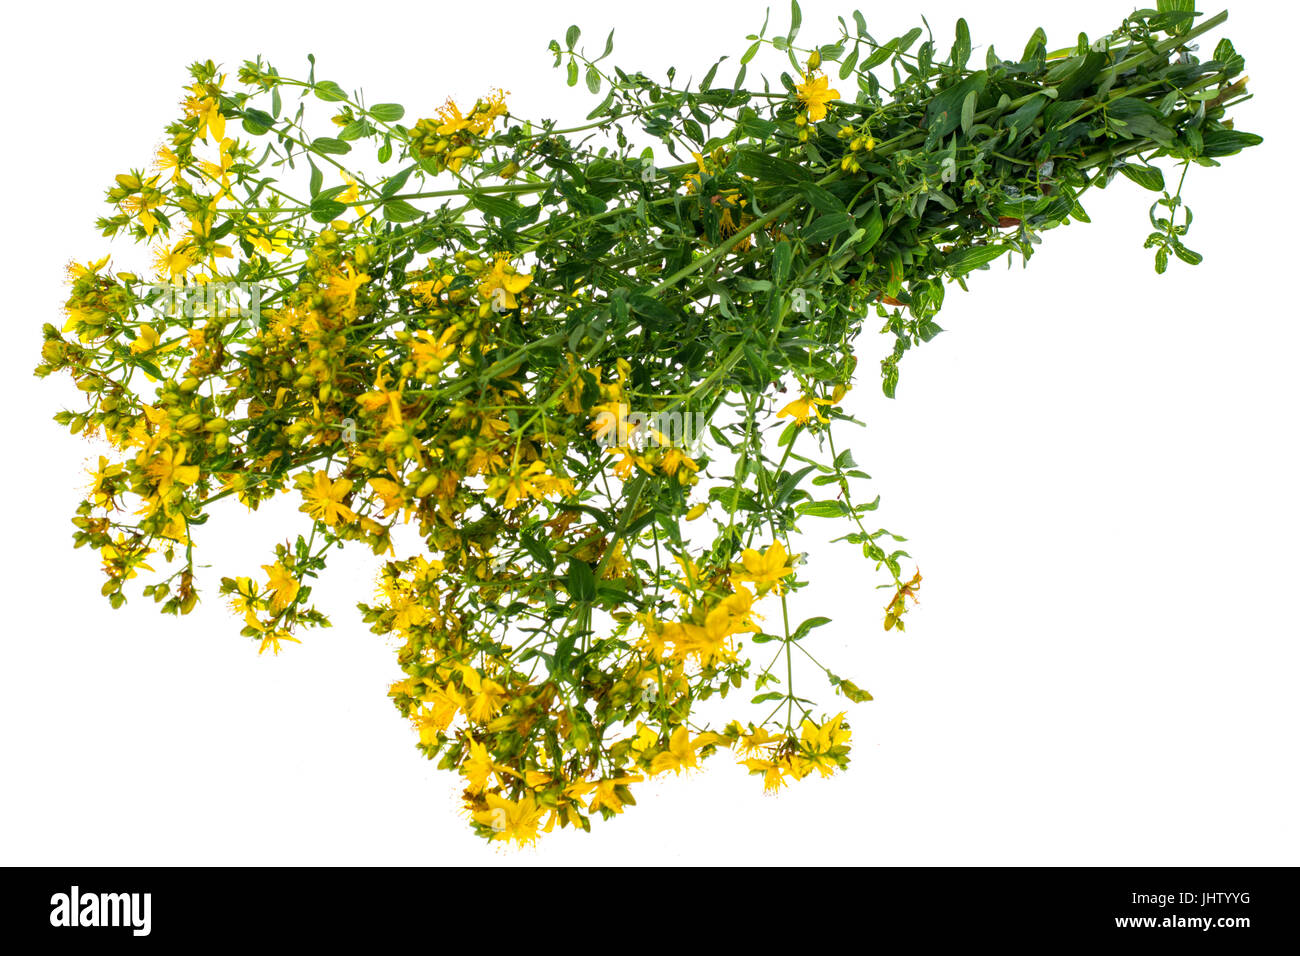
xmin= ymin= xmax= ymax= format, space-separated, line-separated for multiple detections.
xmin=369 ymin=544 xmax=850 ymax=844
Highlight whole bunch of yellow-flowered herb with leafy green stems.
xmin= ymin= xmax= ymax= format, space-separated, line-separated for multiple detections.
xmin=36 ymin=4 xmax=1260 ymax=844
